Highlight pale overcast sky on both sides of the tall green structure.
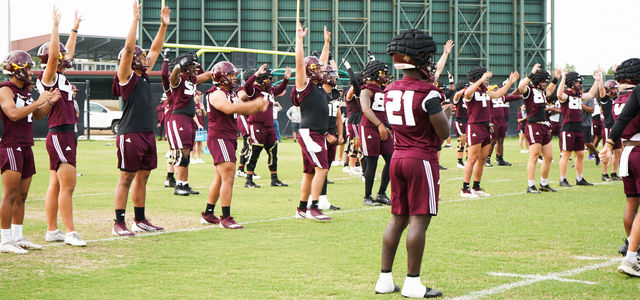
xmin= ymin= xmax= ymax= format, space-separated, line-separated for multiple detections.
xmin=0 ymin=0 xmax=640 ymax=74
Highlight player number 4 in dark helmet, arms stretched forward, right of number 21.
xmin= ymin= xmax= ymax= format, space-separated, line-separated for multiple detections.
xmin=460 ymin=66 xmax=519 ymax=198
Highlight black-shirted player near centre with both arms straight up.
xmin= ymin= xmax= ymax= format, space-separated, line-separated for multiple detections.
xmin=291 ymin=22 xmax=331 ymax=221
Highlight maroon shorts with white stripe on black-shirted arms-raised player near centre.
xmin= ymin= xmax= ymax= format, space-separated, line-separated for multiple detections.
xmin=298 ymin=128 xmax=329 ymax=174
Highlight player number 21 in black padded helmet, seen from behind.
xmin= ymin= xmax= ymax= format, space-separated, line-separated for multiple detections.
xmin=375 ymin=29 xmax=449 ymax=298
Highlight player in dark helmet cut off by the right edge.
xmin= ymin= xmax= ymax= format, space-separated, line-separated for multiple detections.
xmin=600 ymin=58 xmax=640 ymax=277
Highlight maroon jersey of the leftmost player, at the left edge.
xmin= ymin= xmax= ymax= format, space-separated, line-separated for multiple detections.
xmin=0 ymin=81 xmax=33 ymax=148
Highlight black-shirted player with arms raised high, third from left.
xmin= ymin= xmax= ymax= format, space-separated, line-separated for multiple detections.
xmin=111 ymin=1 xmax=171 ymax=236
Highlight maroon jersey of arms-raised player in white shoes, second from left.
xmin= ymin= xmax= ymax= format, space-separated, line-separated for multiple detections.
xmin=36 ymin=72 xmax=78 ymax=128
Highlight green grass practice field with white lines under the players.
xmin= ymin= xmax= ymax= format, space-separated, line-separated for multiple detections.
xmin=0 ymin=139 xmax=640 ymax=299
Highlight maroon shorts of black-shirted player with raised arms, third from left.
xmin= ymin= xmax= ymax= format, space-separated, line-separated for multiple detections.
xmin=116 ymin=131 xmax=158 ymax=172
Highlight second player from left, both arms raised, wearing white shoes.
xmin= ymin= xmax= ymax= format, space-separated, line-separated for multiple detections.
xmin=36 ymin=8 xmax=87 ymax=246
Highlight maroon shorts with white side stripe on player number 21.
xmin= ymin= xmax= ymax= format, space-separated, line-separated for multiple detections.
xmin=389 ymin=158 xmax=440 ymax=216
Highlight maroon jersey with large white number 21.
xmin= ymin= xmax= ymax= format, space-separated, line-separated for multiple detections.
xmin=384 ymin=77 xmax=445 ymax=162
